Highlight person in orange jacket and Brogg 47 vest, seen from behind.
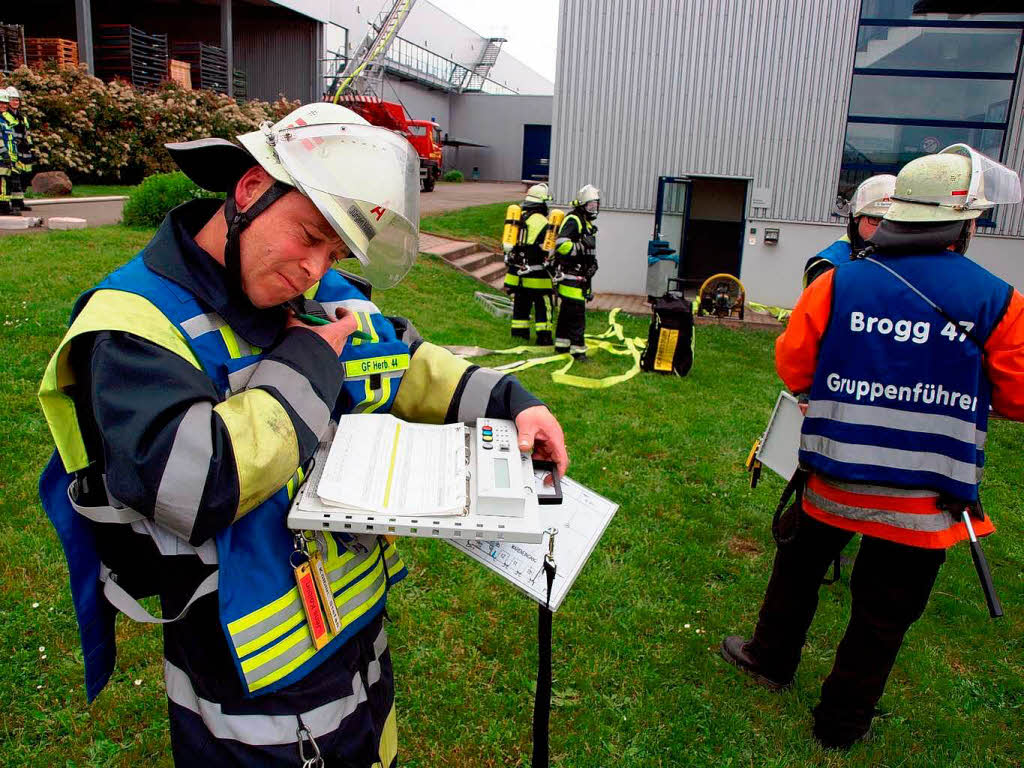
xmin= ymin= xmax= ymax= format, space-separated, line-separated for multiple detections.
xmin=722 ymin=144 xmax=1024 ymax=749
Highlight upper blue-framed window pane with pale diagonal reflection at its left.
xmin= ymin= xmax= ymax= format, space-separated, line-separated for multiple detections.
xmin=853 ymin=27 xmax=1021 ymax=75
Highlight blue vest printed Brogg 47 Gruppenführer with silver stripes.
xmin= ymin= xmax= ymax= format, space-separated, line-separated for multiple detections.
xmin=800 ymin=251 xmax=1013 ymax=502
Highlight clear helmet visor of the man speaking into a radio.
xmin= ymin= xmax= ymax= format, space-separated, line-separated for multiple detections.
xmin=271 ymin=123 xmax=420 ymax=289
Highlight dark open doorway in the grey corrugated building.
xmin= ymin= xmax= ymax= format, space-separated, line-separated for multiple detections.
xmin=680 ymin=176 xmax=748 ymax=288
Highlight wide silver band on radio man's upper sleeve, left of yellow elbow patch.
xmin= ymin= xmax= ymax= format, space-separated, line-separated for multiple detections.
xmin=154 ymin=401 xmax=213 ymax=539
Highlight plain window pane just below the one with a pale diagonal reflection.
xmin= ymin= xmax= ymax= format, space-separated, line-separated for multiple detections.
xmin=850 ymin=75 xmax=1014 ymax=123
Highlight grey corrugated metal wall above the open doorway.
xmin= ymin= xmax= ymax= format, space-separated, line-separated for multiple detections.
xmin=552 ymin=0 xmax=860 ymax=222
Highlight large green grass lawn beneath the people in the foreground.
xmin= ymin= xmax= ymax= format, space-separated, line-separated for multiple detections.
xmin=0 ymin=225 xmax=1024 ymax=768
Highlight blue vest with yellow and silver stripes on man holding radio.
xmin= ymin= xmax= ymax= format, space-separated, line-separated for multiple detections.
xmin=40 ymin=255 xmax=410 ymax=700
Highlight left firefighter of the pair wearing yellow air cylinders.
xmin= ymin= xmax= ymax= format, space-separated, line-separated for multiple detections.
xmin=505 ymin=184 xmax=554 ymax=346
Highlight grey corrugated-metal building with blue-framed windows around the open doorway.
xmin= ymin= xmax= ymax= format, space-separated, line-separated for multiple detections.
xmin=551 ymin=0 xmax=1024 ymax=306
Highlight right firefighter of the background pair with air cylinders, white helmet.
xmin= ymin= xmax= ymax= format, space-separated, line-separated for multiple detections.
xmin=555 ymin=184 xmax=601 ymax=360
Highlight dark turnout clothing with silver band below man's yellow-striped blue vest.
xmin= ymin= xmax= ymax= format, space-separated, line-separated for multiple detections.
xmin=164 ymin=616 xmax=397 ymax=768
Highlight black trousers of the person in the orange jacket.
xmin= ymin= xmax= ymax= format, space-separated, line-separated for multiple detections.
xmin=745 ymin=511 xmax=946 ymax=742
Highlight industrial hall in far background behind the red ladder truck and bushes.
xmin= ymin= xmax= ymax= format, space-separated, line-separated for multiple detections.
xmin=4 ymin=0 xmax=556 ymax=180
